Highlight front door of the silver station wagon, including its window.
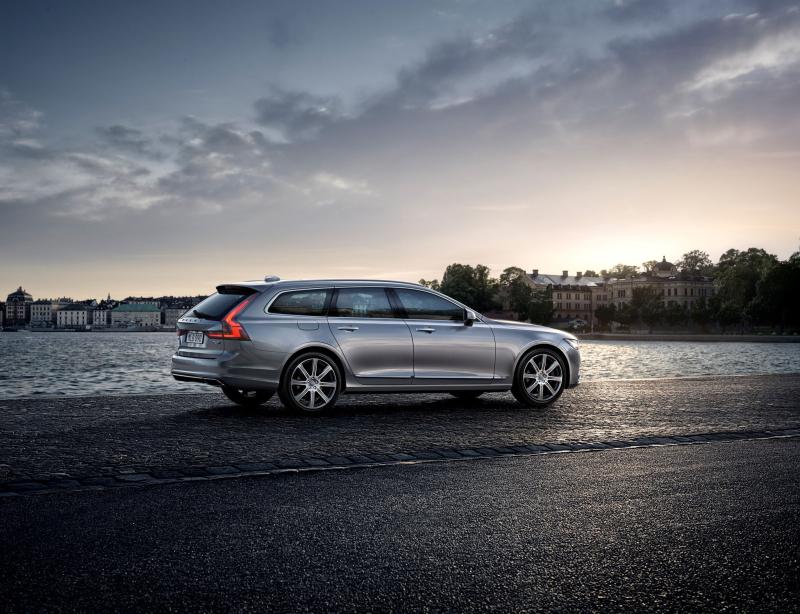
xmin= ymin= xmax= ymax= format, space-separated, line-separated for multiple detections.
xmin=392 ymin=288 xmax=495 ymax=384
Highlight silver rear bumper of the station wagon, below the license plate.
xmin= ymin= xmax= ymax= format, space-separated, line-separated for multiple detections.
xmin=171 ymin=352 xmax=278 ymax=390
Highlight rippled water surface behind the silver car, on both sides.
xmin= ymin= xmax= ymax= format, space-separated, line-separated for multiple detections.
xmin=0 ymin=332 xmax=800 ymax=399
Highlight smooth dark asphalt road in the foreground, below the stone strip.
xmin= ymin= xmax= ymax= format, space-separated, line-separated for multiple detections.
xmin=0 ymin=439 xmax=800 ymax=612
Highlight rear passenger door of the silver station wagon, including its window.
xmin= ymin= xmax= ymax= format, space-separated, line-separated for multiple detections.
xmin=328 ymin=286 xmax=414 ymax=385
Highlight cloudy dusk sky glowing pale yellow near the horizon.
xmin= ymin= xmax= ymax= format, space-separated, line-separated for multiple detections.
xmin=0 ymin=0 xmax=800 ymax=298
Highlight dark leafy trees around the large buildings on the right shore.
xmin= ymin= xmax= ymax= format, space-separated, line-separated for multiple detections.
xmin=420 ymin=247 xmax=800 ymax=332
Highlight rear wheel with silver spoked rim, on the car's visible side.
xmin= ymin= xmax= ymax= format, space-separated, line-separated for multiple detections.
xmin=278 ymin=352 xmax=342 ymax=414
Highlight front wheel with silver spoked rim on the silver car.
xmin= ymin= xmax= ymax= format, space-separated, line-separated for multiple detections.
xmin=511 ymin=347 xmax=567 ymax=407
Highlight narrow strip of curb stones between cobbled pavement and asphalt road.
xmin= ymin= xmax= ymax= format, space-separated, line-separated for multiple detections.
xmin=0 ymin=428 xmax=800 ymax=500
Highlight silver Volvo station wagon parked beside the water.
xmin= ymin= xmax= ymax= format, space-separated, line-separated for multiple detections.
xmin=172 ymin=276 xmax=580 ymax=413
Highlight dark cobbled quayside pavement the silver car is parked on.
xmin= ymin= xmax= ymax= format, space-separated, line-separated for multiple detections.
xmin=0 ymin=375 xmax=800 ymax=482
